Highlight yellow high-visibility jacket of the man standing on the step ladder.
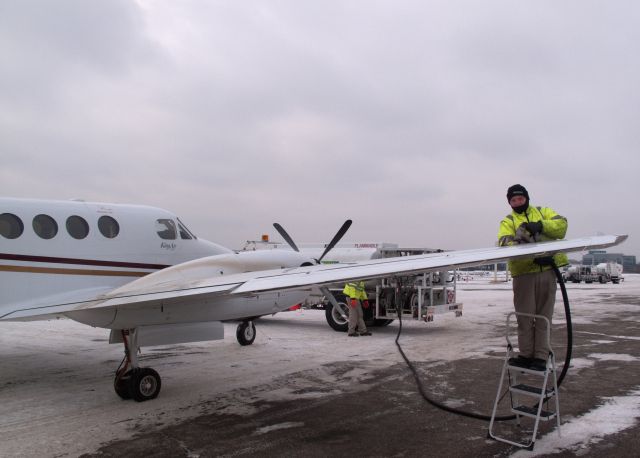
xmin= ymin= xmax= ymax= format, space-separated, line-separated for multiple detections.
xmin=498 ymin=205 xmax=569 ymax=277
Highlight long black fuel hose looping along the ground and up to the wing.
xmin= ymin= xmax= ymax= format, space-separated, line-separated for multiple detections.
xmin=395 ymin=263 xmax=573 ymax=421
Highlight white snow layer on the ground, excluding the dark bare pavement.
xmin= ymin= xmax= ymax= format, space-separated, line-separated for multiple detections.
xmin=0 ymin=275 xmax=640 ymax=456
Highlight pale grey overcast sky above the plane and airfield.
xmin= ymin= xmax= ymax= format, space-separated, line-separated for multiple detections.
xmin=0 ymin=0 xmax=640 ymax=256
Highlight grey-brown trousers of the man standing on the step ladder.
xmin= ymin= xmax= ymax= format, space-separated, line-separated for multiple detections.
xmin=513 ymin=270 xmax=558 ymax=360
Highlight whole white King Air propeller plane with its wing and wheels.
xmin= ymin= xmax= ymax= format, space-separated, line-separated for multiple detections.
xmin=0 ymin=198 xmax=627 ymax=402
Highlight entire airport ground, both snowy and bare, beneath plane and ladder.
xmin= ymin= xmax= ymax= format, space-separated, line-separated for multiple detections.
xmin=0 ymin=275 xmax=640 ymax=458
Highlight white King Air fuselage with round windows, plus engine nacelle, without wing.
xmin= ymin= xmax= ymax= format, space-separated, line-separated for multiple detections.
xmin=0 ymin=198 xmax=308 ymax=329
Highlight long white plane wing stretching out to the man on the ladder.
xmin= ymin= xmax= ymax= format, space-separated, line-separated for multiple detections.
xmin=0 ymin=235 xmax=627 ymax=321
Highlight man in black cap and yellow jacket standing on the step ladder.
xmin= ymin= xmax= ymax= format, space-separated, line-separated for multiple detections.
xmin=498 ymin=184 xmax=569 ymax=370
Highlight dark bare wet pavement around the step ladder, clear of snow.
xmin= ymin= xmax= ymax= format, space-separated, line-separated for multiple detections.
xmin=82 ymin=280 xmax=640 ymax=458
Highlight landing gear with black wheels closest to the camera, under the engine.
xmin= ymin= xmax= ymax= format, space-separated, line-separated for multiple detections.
xmin=113 ymin=329 xmax=162 ymax=402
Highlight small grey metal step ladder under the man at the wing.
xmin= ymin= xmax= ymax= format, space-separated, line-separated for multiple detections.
xmin=488 ymin=312 xmax=560 ymax=450
